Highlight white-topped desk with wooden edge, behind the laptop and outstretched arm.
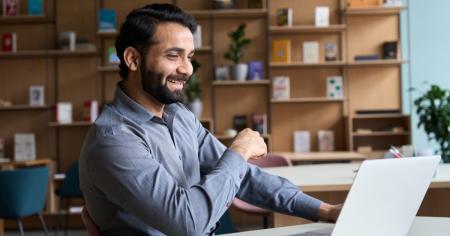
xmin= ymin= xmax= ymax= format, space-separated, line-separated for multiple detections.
xmin=264 ymin=163 xmax=450 ymax=227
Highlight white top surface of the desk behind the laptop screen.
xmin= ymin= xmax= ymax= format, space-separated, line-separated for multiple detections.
xmin=264 ymin=163 xmax=450 ymax=192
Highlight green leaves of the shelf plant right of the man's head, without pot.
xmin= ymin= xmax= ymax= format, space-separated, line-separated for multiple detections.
xmin=224 ymin=24 xmax=251 ymax=64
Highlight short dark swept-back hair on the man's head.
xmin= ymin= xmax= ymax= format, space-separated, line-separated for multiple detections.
xmin=116 ymin=3 xmax=197 ymax=79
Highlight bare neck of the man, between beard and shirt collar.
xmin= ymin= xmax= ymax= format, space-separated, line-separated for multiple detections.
xmin=121 ymin=80 xmax=164 ymax=119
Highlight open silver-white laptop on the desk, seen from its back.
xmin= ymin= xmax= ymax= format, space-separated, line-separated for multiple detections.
xmin=293 ymin=156 xmax=441 ymax=236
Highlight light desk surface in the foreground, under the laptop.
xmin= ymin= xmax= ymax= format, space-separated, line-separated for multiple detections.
xmin=227 ymin=217 xmax=450 ymax=236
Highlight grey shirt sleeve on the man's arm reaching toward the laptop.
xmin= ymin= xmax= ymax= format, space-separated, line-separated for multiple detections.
xmin=193 ymin=117 xmax=322 ymax=221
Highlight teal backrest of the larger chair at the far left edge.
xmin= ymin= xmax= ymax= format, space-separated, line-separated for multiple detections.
xmin=0 ymin=166 xmax=49 ymax=219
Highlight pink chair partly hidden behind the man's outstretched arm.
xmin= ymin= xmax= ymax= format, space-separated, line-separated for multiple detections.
xmin=233 ymin=154 xmax=292 ymax=229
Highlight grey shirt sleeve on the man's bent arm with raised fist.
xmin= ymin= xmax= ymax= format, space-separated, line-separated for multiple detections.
xmin=88 ymin=124 xmax=248 ymax=235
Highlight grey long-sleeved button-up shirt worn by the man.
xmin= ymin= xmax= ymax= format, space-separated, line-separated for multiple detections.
xmin=80 ymin=85 xmax=321 ymax=235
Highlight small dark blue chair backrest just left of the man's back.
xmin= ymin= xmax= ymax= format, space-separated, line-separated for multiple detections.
xmin=57 ymin=162 xmax=83 ymax=198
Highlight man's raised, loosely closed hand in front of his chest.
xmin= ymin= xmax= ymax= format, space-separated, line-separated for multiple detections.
xmin=230 ymin=128 xmax=267 ymax=161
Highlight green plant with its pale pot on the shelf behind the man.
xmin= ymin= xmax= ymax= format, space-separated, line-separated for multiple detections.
xmin=224 ymin=24 xmax=251 ymax=80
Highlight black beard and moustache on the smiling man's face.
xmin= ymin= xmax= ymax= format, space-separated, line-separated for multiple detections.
xmin=141 ymin=63 xmax=187 ymax=104
